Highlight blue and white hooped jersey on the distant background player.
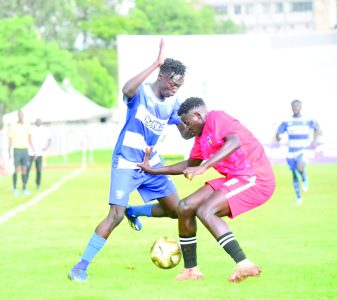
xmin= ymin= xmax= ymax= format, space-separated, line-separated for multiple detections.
xmin=277 ymin=117 xmax=318 ymax=158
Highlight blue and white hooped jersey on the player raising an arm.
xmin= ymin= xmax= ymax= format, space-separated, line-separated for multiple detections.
xmin=112 ymin=83 xmax=182 ymax=169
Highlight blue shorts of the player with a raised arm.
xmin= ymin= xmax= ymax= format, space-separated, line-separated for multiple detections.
xmin=109 ymin=168 xmax=176 ymax=207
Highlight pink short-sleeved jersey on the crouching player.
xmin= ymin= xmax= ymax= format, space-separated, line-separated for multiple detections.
xmin=190 ymin=111 xmax=274 ymax=184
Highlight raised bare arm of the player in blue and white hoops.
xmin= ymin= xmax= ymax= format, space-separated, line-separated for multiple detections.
xmin=122 ymin=39 xmax=165 ymax=98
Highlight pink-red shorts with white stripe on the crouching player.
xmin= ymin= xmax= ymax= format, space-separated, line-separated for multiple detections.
xmin=206 ymin=176 xmax=275 ymax=218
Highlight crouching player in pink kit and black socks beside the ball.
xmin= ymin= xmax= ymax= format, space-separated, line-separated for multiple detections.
xmin=139 ymin=97 xmax=275 ymax=282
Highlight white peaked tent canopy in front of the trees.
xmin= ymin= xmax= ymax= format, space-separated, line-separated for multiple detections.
xmin=4 ymin=74 xmax=111 ymax=123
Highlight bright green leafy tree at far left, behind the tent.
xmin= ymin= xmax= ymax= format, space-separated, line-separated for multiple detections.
xmin=0 ymin=17 xmax=77 ymax=111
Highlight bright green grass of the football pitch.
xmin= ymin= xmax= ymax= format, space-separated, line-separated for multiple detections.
xmin=0 ymin=152 xmax=337 ymax=300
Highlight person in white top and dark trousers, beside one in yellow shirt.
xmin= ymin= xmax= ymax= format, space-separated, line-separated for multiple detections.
xmin=27 ymin=118 xmax=51 ymax=189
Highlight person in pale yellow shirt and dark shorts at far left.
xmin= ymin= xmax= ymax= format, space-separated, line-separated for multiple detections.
xmin=8 ymin=110 xmax=34 ymax=196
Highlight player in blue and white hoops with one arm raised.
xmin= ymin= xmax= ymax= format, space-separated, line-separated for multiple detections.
xmin=68 ymin=40 xmax=192 ymax=281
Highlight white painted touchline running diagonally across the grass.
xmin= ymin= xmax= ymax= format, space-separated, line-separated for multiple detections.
xmin=0 ymin=168 xmax=84 ymax=225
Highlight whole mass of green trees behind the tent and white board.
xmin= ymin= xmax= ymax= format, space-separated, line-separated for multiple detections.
xmin=0 ymin=0 xmax=242 ymax=118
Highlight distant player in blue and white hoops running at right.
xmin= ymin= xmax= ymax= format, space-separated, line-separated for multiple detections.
xmin=276 ymin=100 xmax=320 ymax=205
